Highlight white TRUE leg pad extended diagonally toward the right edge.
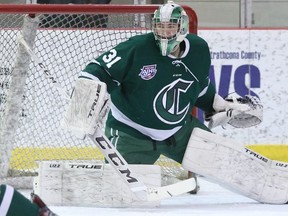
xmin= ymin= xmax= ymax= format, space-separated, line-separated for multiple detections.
xmin=182 ymin=128 xmax=288 ymax=204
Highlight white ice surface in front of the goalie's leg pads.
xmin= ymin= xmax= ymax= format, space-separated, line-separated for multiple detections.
xmin=42 ymin=178 xmax=288 ymax=216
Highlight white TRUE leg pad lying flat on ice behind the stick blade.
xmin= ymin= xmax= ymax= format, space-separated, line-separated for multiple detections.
xmin=34 ymin=161 xmax=161 ymax=207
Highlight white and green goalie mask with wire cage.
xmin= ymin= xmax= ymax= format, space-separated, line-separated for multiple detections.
xmin=152 ymin=1 xmax=189 ymax=56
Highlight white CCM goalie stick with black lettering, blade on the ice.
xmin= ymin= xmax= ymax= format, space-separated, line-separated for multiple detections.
xmin=18 ymin=34 xmax=197 ymax=201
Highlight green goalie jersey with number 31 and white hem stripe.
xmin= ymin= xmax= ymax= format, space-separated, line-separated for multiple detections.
xmin=80 ymin=33 xmax=215 ymax=140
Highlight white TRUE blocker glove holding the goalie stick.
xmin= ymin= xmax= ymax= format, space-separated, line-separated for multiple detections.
xmin=61 ymin=78 xmax=109 ymax=139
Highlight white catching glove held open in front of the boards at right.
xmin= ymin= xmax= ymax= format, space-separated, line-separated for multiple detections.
xmin=205 ymin=94 xmax=263 ymax=129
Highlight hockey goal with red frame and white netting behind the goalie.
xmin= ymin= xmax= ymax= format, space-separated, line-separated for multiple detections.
xmin=0 ymin=4 xmax=197 ymax=188
